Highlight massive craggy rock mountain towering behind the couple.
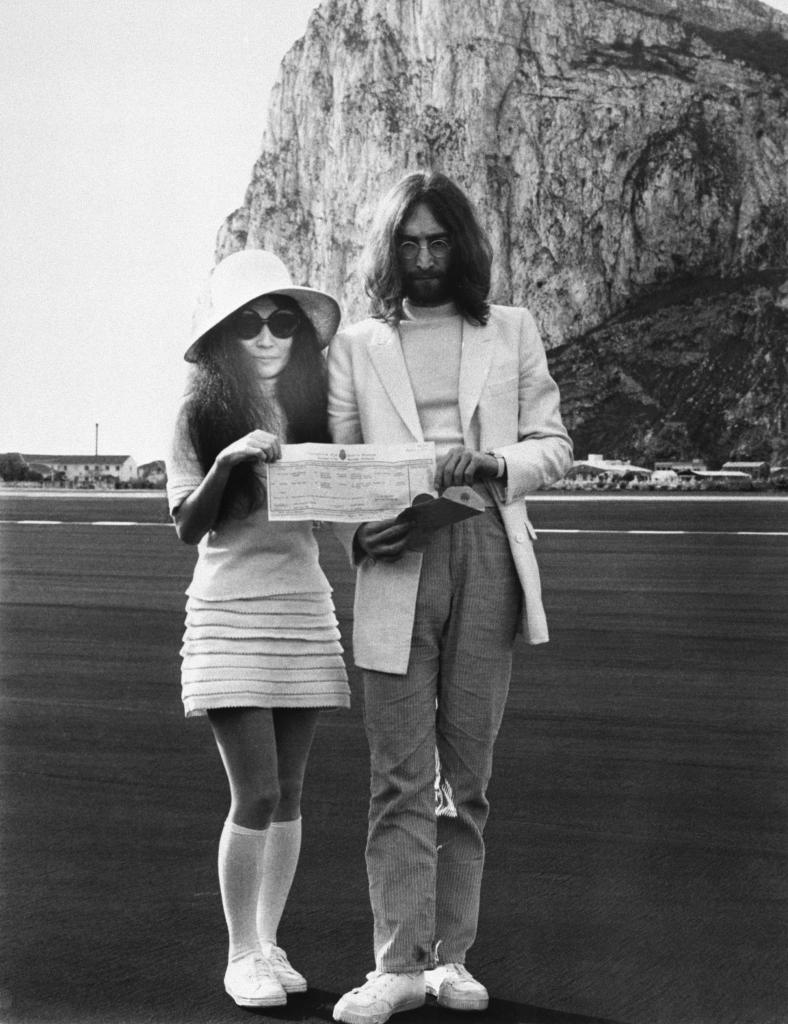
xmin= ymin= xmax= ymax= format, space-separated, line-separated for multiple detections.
xmin=218 ymin=0 xmax=788 ymax=459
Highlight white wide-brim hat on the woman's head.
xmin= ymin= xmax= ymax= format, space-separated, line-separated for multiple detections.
xmin=188 ymin=249 xmax=342 ymax=362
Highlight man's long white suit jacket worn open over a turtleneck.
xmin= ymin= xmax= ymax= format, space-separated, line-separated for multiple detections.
xmin=329 ymin=306 xmax=572 ymax=673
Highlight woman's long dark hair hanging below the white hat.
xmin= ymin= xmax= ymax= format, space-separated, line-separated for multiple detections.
xmin=187 ymin=295 xmax=331 ymax=523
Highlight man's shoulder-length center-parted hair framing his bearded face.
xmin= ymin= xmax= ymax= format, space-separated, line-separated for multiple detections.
xmin=362 ymin=171 xmax=492 ymax=325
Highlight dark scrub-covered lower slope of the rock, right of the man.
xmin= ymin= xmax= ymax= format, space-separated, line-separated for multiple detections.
xmin=550 ymin=270 xmax=788 ymax=468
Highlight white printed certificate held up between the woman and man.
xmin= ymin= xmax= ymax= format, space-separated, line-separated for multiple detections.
xmin=267 ymin=441 xmax=435 ymax=522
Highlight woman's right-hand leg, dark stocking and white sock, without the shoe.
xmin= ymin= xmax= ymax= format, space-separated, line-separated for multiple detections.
xmin=257 ymin=708 xmax=319 ymax=948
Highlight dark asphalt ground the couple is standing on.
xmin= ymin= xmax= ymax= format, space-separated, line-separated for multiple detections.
xmin=0 ymin=492 xmax=788 ymax=1024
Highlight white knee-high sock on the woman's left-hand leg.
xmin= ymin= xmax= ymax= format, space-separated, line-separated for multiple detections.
xmin=219 ymin=820 xmax=268 ymax=959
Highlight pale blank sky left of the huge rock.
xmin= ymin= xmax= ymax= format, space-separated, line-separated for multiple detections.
xmin=0 ymin=0 xmax=788 ymax=463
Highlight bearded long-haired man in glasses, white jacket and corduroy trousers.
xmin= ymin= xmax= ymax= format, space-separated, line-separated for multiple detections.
xmin=329 ymin=173 xmax=572 ymax=1024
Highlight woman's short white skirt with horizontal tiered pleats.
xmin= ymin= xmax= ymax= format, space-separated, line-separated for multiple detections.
xmin=180 ymin=593 xmax=350 ymax=718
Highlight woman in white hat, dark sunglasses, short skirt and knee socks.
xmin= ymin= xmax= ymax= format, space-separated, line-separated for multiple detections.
xmin=167 ymin=250 xmax=349 ymax=1007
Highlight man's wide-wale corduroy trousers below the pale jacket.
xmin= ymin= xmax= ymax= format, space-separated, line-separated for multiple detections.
xmin=363 ymin=508 xmax=522 ymax=973
